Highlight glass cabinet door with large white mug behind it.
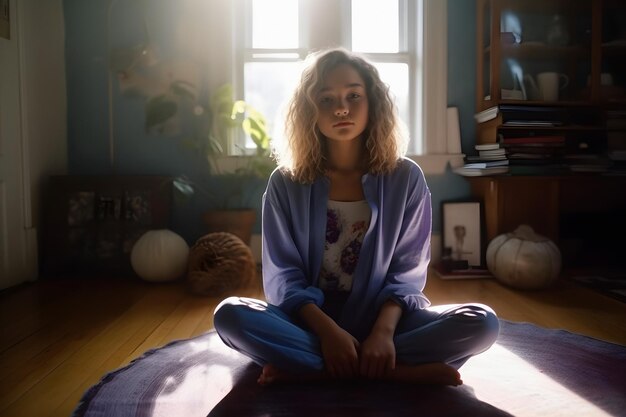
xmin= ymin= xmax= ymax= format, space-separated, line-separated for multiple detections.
xmin=493 ymin=0 xmax=592 ymax=102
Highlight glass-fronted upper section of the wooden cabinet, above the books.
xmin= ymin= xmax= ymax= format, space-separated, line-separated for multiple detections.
xmin=476 ymin=0 xmax=626 ymax=111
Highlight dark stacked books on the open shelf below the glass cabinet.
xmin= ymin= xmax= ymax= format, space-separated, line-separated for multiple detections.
xmin=472 ymin=104 xmax=608 ymax=175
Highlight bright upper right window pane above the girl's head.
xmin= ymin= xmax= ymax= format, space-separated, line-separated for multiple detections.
xmin=352 ymin=0 xmax=400 ymax=53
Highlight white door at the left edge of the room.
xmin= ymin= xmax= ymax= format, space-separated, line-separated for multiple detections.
xmin=0 ymin=1 xmax=36 ymax=289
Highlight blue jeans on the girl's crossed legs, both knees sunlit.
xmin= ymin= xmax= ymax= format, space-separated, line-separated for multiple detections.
xmin=214 ymin=297 xmax=500 ymax=373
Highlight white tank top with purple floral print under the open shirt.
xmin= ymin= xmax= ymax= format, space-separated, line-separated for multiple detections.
xmin=319 ymin=200 xmax=371 ymax=292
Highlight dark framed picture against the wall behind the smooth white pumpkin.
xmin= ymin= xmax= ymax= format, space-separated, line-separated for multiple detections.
xmin=41 ymin=175 xmax=172 ymax=277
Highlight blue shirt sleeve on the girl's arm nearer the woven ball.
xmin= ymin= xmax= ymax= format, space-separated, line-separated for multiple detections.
xmin=262 ymin=171 xmax=324 ymax=315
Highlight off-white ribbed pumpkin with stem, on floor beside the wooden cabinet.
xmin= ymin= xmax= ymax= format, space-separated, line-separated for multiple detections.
xmin=487 ymin=225 xmax=561 ymax=289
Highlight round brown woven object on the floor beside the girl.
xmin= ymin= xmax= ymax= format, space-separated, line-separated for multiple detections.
xmin=187 ymin=232 xmax=256 ymax=296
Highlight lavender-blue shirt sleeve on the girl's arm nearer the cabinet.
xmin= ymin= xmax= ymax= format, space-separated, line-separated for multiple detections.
xmin=375 ymin=162 xmax=432 ymax=310
